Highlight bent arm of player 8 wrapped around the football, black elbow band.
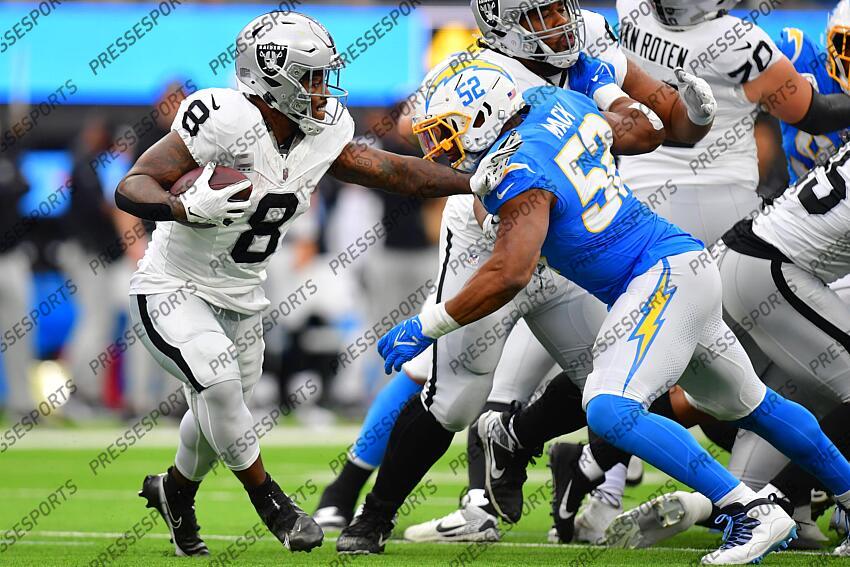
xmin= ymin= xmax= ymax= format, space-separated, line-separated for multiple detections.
xmin=115 ymin=132 xmax=198 ymax=221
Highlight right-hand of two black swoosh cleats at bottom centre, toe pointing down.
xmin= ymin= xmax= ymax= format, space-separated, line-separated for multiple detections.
xmin=549 ymin=443 xmax=604 ymax=543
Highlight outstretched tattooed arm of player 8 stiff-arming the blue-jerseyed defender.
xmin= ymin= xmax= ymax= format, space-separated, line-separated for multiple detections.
xmin=329 ymin=142 xmax=470 ymax=198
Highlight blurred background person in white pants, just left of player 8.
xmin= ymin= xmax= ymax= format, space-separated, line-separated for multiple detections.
xmin=57 ymin=117 xmax=156 ymax=419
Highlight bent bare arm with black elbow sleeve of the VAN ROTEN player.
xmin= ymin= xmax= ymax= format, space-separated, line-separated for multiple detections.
xmin=744 ymin=55 xmax=850 ymax=135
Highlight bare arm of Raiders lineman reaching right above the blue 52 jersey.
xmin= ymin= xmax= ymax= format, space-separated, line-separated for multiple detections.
xmin=614 ymin=59 xmax=713 ymax=144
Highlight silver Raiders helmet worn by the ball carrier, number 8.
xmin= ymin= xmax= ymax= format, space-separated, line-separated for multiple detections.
xmin=236 ymin=11 xmax=348 ymax=136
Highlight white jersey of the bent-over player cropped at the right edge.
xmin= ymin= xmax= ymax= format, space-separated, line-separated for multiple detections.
xmin=753 ymin=144 xmax=850 ymax=283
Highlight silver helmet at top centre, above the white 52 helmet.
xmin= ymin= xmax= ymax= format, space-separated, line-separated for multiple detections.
xmin=472 ymin=0 xmax=585 ymax=69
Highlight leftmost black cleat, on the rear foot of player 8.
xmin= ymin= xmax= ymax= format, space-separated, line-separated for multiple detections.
xmin=139 ymin=472 xmax=210 ymax=557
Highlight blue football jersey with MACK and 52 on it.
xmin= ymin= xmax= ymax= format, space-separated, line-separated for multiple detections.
xmin=483 ymin=87 xmax=703 ymax=305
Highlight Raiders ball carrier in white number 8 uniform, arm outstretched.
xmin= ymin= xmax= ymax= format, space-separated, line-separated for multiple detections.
xmin=115 ymin=12 xmax=470 ymax=556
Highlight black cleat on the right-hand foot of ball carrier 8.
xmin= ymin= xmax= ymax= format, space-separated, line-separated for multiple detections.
xmin=248 ymin=476 xmax=325 ymax=553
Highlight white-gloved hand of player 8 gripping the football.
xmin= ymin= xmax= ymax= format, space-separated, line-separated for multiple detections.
xmin=178 ymin=162 xmax=251 ymax=226
